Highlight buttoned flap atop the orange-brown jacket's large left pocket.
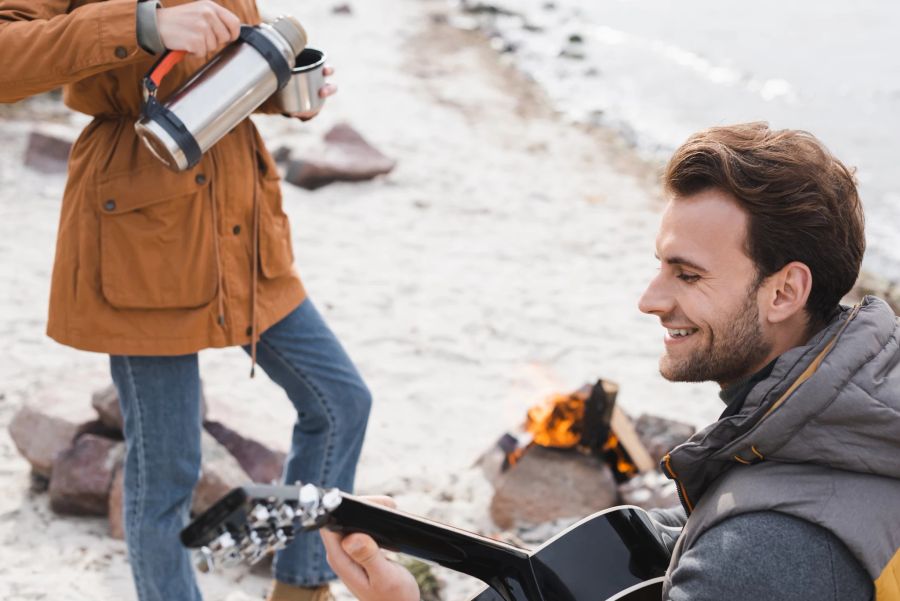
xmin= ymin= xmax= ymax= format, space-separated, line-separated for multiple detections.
xmin=97 ymin=165 xmax=209 ymax=215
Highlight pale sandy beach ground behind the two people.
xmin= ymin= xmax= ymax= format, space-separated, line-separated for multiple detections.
xmin=0 ymin=0 xmax=720 ymax=601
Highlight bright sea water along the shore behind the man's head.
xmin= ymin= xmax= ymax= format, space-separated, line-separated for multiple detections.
xmin=460 ymin=0 xmax=900 ymax=280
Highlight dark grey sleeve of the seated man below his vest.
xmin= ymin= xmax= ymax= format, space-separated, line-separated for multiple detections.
xmin=665 ymin=511 xmax=874 ymax=601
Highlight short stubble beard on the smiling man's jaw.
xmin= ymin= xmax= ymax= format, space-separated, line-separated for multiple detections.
xmin=659 ymin=286 xmax=772 ymax=384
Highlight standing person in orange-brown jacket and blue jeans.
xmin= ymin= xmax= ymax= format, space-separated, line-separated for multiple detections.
xmin=0 ymin=0 xmax=371 ymax=601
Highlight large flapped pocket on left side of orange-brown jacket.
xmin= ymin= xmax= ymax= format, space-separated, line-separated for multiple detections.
xmin=98 ymin=170 xmax=218 ymax=309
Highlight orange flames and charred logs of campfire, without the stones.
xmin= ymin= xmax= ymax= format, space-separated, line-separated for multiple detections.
xmin=499 ymin=380 xmax=654 ymax=483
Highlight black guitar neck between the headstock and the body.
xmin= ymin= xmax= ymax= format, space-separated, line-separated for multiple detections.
xmin=325 ymin=494 xmax=542 ymax=601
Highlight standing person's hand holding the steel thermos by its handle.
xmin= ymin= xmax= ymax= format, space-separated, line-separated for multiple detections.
xmin=156 ymin=0 xmax=241 ymax=57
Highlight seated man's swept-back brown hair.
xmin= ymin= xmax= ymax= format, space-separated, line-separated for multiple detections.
xmin=665 ymin=123 xmax=866 ymax=327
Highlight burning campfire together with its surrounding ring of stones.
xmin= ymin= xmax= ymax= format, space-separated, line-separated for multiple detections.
xmin=477 ymin=380 xmax=694 ymax=528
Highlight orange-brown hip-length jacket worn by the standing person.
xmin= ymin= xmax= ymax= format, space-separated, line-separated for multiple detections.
xmin=0 ymin=0 xmax=305 ymax=355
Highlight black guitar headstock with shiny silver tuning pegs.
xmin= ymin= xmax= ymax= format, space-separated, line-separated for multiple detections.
xmin=181 ymin=483 xmax=342 ymax=572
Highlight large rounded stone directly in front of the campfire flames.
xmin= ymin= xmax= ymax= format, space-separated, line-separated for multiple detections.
xmin=490 ymin=445 xmax=619 ymax=529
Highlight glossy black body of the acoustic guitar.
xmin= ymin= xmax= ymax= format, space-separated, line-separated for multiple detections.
xmin=472 ymin=507 xmax=669 ymax=601
